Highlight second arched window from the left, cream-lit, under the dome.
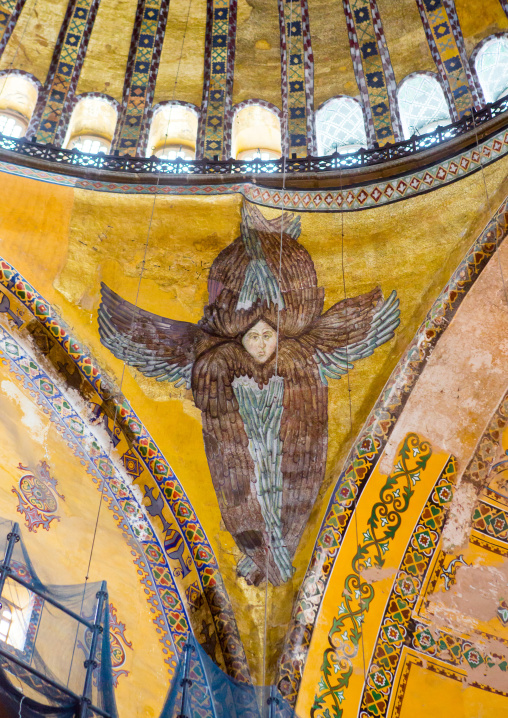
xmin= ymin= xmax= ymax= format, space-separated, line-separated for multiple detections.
xmin=65 ymin=96 xmax=117 ymax=155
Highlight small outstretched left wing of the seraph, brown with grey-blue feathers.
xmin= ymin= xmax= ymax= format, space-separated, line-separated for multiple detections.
xmin=99 ymin=283 xmax=211 ymax=388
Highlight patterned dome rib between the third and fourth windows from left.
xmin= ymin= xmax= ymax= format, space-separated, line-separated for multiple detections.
xmin=196 ymin=0 xmax=237 ymax=160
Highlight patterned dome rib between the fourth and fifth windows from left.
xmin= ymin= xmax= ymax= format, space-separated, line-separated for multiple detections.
xmin=278 ymin=0 xmax=317 ymax=157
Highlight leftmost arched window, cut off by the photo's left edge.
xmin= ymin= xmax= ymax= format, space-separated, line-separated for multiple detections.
xmin=0 ymin=73 xmax=38 ymax=137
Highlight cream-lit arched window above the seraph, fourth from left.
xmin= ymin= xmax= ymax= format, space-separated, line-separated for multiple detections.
xmin=231 ymin=104 xmax=282 ymax=161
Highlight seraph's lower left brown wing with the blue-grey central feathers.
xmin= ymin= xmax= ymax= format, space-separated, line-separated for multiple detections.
xmin=192 ymin=340 xmax=290 ymax=585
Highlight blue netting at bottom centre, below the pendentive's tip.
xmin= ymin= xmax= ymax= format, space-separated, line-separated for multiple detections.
xmin=160 ymin=634 xmax=296 ymax=718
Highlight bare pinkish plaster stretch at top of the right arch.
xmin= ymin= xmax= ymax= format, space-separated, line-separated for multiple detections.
xmin=381 ymin=242 xmax=508 ymax=480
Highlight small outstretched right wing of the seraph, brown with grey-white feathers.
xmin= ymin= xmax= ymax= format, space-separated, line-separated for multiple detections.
xmin=306 ymin=287 xmax=400 ymax=385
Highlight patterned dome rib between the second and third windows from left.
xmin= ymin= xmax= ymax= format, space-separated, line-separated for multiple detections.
xmin=112 ymin=0 xmax=169 ymax=157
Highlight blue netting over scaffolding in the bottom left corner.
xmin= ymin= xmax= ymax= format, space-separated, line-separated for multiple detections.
xmin=0 ymin=519 xmax=117 ymax=718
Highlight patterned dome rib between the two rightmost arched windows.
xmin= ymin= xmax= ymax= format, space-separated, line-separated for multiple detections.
xmin=416 ymin=0 xmax=485 ymax=120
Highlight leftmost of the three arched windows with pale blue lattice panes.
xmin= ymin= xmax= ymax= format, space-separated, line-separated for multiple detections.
xmin=316 ymin=97 xmax=367 ymax=157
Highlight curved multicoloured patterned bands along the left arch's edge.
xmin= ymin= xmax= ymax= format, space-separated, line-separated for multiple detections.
xmin=0 ymin=264 xmax=250 ymax=682
